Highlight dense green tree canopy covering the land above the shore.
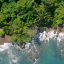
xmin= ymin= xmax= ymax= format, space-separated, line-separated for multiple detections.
xmin=0 ymin=0 xmax=64 ymax=43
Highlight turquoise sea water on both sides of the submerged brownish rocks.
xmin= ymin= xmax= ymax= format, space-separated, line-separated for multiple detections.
xmin=0 ymin=39 xmax=64 ymax=64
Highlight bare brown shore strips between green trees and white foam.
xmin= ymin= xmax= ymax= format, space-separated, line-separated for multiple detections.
xmin=0 ymin=27 xmax=64 ymax=45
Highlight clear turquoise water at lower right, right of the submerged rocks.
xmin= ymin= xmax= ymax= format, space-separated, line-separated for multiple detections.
xmin=36 ymin=40 xmax=64 ymax=64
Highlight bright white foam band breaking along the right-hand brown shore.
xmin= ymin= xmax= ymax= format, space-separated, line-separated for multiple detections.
xmin=39 ymin=30 xmax=64 ymax=42
